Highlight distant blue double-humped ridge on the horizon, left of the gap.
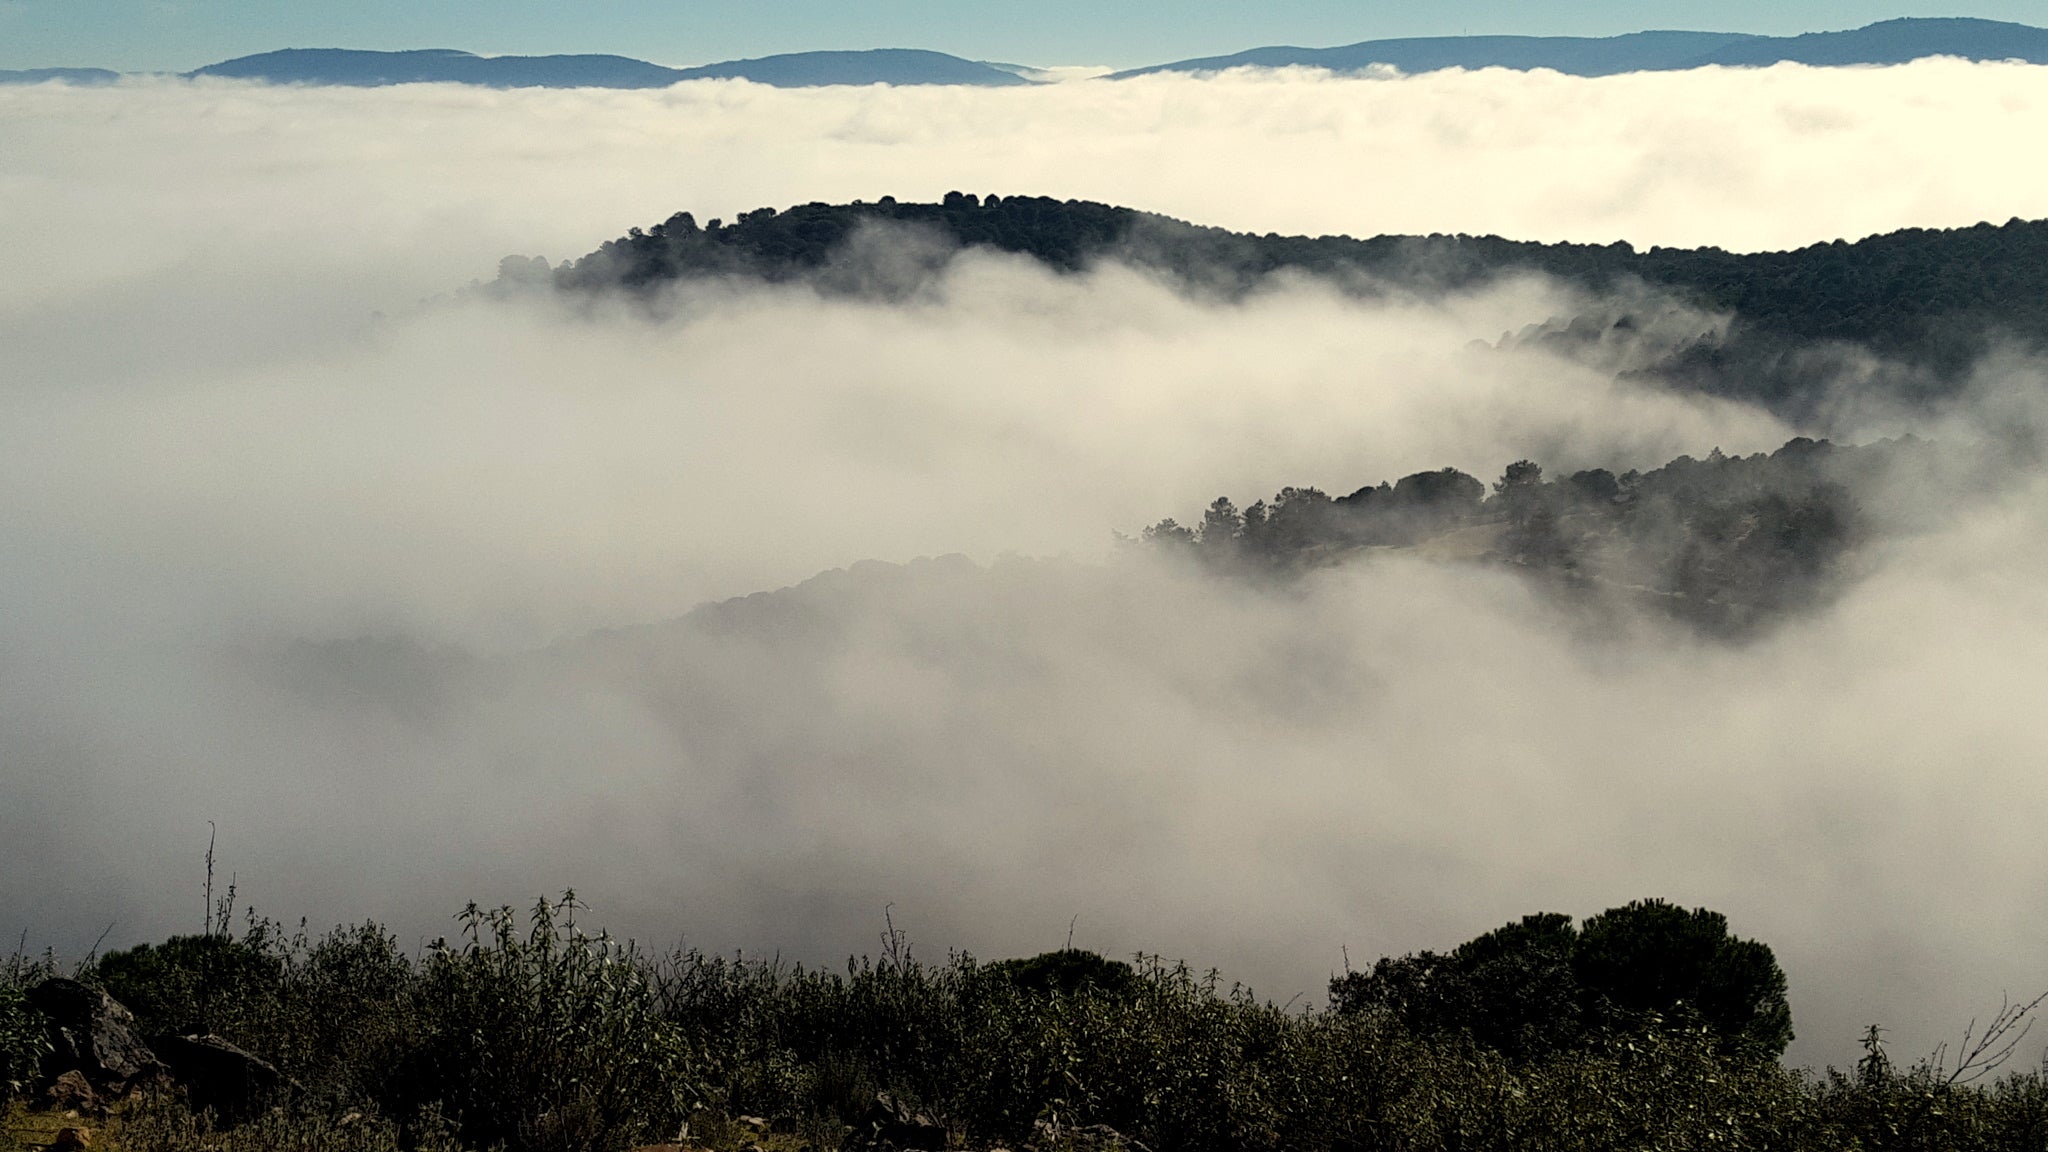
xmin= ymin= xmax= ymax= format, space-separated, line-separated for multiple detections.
xmin=186 ymin=47 xmax=1028 ymax=88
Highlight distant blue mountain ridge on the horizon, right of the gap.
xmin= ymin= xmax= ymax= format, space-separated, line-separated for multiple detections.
xmin=1110 ymin=16 xmax=2048 ymax=80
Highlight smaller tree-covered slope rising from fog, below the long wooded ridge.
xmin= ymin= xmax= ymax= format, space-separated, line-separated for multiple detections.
xmin=1143 ymin=437 xmax=1958 ymax=637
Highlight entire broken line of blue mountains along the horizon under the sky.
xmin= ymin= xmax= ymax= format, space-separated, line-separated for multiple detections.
xmin=12 ymin=18 xmax=2048 ymax=88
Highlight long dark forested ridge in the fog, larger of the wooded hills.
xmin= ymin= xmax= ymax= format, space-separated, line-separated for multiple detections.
xmin=536 ymin=193 xmax=2048 ymax=414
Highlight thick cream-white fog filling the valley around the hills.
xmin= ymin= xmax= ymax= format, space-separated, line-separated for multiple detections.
xmin=0 ymin=61 xmax=2048 ymax=1062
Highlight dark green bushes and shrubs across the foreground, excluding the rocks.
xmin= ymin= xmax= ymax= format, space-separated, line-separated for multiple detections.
xmin=0 ymin=898 xmax=2048 ymax=1152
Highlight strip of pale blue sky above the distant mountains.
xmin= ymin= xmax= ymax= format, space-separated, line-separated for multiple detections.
xmin=0 ymin=0 xmax=2048 ymax=70
